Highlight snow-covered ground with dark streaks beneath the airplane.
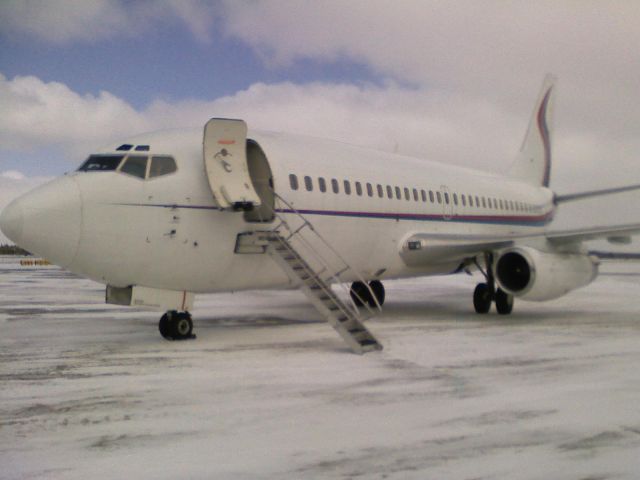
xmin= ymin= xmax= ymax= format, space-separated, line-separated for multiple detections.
xmin=0 ymin=258 xmax=640 ymax=479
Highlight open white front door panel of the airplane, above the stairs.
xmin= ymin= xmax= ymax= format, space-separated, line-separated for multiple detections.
xmin=202 ymin=118 xmax=260 ymax=210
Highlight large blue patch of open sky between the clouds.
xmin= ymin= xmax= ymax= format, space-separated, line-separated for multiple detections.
xmin=1 ymin=18 xmax=381 ymax=108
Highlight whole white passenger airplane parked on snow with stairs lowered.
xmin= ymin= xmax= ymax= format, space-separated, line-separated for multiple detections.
xmin=0 ymin=75 xmax=640 ymax=353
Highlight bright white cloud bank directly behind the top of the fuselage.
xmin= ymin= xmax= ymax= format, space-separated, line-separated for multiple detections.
xmin=0 ymin=75 xmax=534 ymax=173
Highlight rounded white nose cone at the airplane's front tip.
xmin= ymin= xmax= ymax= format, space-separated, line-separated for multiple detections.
xmin=0 ymin=177 xmax=82 ymax=267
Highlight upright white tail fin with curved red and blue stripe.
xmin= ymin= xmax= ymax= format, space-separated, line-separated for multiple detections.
xmin=508 ymin=75 xmax=556 ymax=187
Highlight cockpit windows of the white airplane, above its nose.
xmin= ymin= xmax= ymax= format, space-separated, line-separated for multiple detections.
xmin=78 ymin=155 xmax=177 ymax=179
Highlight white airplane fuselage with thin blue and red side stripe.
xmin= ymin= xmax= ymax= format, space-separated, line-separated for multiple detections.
xmin=1 ymin=129 xmax=554 ymax=293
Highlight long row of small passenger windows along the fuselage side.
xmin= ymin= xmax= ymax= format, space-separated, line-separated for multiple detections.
xmin=289 ymin=173 xmax=534 ymax=212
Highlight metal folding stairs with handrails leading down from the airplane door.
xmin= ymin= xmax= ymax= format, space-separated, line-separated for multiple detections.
xmin=235 ymin=196 xmax=382 ymax=354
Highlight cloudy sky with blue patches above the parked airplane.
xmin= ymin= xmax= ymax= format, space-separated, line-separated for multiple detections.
xmin=0 ymin=0 xmax=640 ymax=244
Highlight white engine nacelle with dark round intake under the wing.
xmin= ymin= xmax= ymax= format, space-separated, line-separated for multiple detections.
xmin=495 ymin=247 xmax=598 ymax=301
